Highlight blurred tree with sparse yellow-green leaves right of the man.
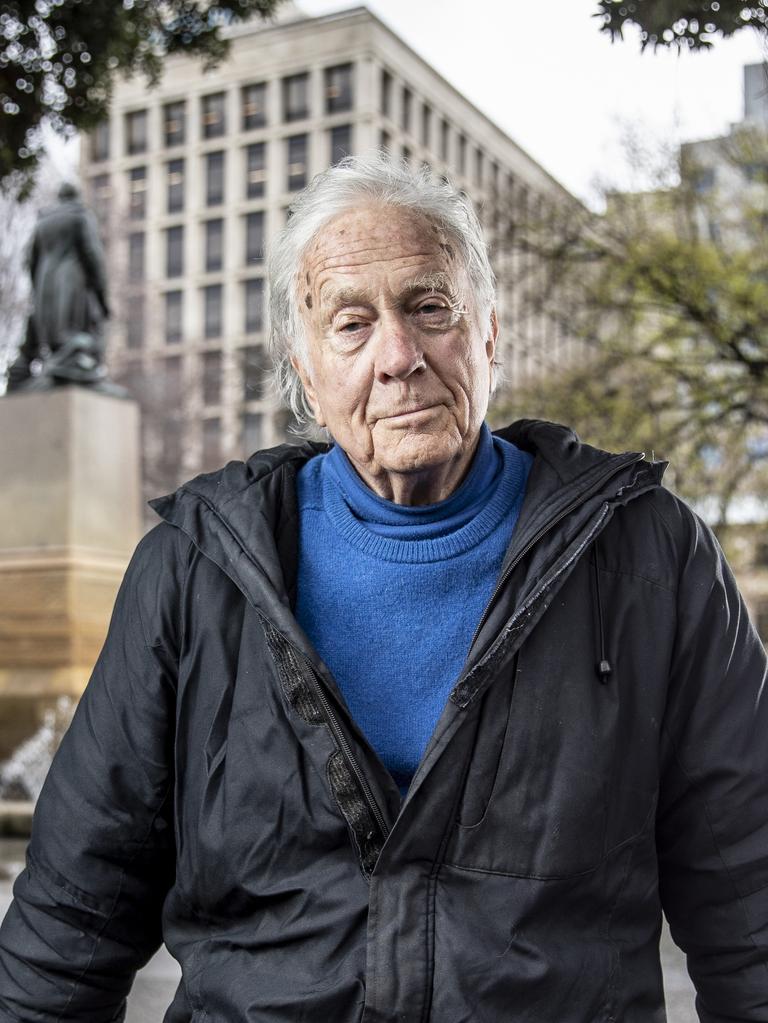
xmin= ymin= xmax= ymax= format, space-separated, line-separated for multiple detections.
xmin=488 ymin=129 xmax=768 ymax=521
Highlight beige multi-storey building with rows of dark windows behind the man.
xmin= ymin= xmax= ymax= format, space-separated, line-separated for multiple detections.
xmin=82 ymin=7 xmax=571 ymax=507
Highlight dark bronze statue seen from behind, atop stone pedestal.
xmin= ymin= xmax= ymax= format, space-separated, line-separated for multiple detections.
xmin=8 ymin=183 xmax=117 ymax=391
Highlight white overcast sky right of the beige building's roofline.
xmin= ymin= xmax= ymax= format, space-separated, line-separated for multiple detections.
xmin=299 ymin=0 xmax=766 ymax=198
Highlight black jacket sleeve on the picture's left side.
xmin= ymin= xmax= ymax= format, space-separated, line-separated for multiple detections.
xmin=0 ymin=525 xmax=189 ymax=1023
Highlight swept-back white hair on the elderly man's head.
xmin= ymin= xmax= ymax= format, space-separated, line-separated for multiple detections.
xmin=268 ymin=152 xmax=496 ymax=427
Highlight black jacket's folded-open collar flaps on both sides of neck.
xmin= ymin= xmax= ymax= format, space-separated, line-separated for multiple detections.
xmin=149 ymin=419 xmax=666 ymax=630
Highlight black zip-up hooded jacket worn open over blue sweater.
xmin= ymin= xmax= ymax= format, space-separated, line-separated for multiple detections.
xmin=0 ymin=421 xmax=768 ymax=1023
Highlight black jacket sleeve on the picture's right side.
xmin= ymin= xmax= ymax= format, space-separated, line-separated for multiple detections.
xmin=657 ymin=507 xmax=768 ymax=1023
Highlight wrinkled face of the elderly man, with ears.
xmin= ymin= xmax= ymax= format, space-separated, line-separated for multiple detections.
xmin=295 ymin=205 xmax=496 ymax=504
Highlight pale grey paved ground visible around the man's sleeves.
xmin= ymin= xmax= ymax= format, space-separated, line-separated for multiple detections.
xmin=0 ymin=840 xmax=697 ymax=1023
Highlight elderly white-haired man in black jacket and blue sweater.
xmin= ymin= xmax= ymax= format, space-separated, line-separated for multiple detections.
xmin=0 ymin=155 xmax=768 ymax=1023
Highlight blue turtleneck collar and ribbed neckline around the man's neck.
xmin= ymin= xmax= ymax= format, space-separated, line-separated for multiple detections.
xmin=321 ymin=425 xmax=529 ymax=563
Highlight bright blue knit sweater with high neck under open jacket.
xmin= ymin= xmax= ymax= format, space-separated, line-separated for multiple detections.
xmin=296 ymin=427 xmax=532 ymax=791
